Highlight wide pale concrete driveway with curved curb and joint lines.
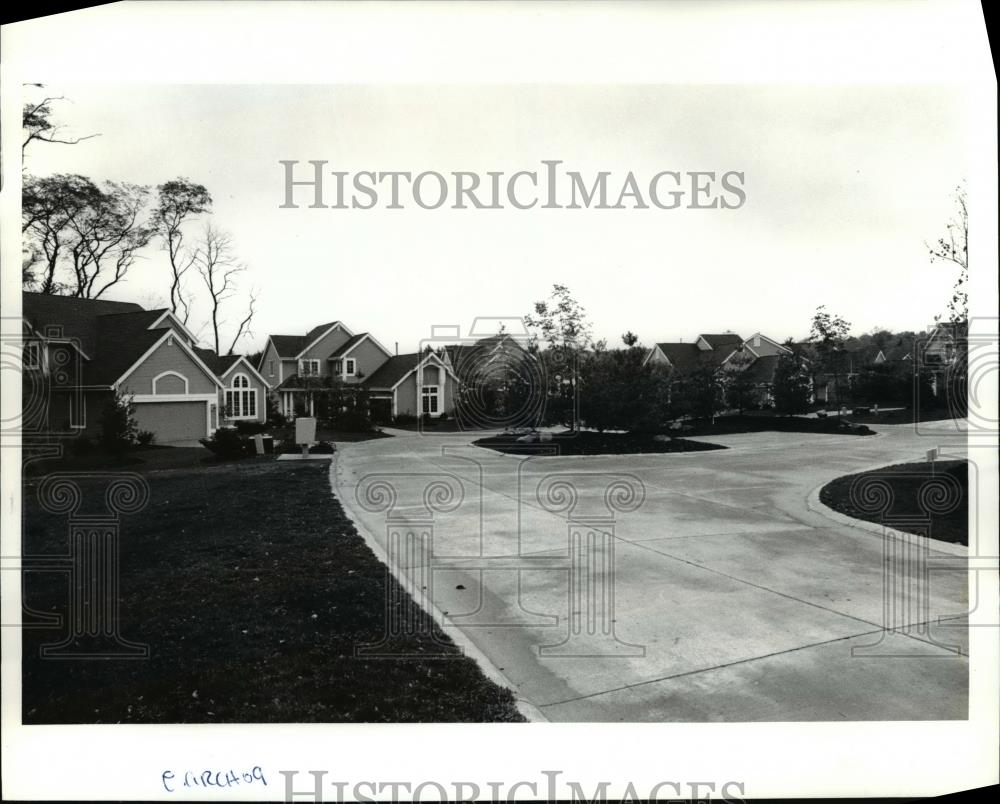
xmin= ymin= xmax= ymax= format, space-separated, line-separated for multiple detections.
xmin=331 ymin=422 xmax=968 ymax=722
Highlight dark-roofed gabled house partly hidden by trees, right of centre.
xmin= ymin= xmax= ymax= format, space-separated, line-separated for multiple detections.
xmin=644 ymin=332 xmax=792 ymax=405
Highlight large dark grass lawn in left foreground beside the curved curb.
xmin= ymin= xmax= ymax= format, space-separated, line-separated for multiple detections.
xmin=23 ymin=457 xmax=522 ymax=724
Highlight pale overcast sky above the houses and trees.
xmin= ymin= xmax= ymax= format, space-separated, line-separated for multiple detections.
xmin=26 ymin=84 xmax=967 ymax=352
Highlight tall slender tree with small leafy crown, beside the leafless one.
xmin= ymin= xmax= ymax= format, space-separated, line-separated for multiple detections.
xmin=152 ymin=177 xmax=212 ymax=324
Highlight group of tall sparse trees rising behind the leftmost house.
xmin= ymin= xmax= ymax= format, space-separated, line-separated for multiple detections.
xmin=21 ymin=85 xmax=257 ymax=354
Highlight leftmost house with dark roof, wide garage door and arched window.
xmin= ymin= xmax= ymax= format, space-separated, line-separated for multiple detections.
xmin=22 ymin=292 xmax=267 ymax=444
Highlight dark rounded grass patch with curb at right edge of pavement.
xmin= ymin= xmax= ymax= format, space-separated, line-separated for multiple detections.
xmin=819 ymin=461 xmax=969 ymax=545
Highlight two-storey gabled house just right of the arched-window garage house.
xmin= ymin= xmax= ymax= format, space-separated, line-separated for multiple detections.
xmin=259 ymin=321 xmax=457 ymax=422
